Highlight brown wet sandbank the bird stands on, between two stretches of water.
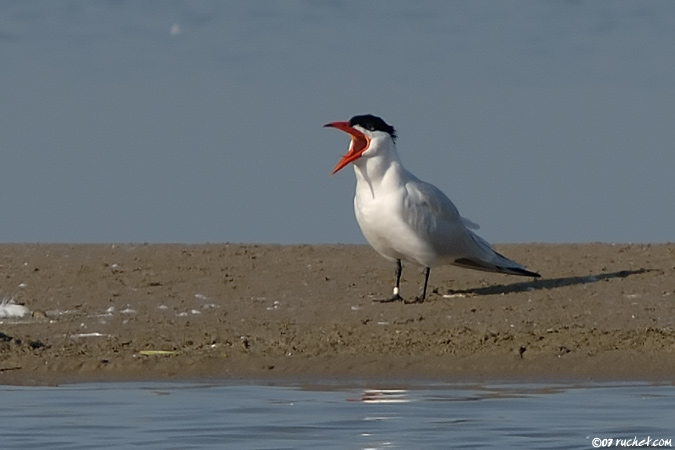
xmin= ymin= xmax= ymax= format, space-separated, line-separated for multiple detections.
xmin=0 ymin=244 xmax=675 ymax=384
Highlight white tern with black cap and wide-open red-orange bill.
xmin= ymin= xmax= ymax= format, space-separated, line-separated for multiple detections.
xmin=324 ymin=114 xmax=540 ymax=302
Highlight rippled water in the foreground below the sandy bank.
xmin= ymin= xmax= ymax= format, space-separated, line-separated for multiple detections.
xmin=0 ymin=382 xmax=675 ymax=449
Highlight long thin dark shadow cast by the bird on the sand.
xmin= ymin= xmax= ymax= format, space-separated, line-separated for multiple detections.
xmin=448 ymin=269 xmax=654 ymax=295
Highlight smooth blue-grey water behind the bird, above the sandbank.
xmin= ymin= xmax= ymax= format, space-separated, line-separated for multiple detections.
xmin=0 ymin=0 xmax=675 ymax=244
